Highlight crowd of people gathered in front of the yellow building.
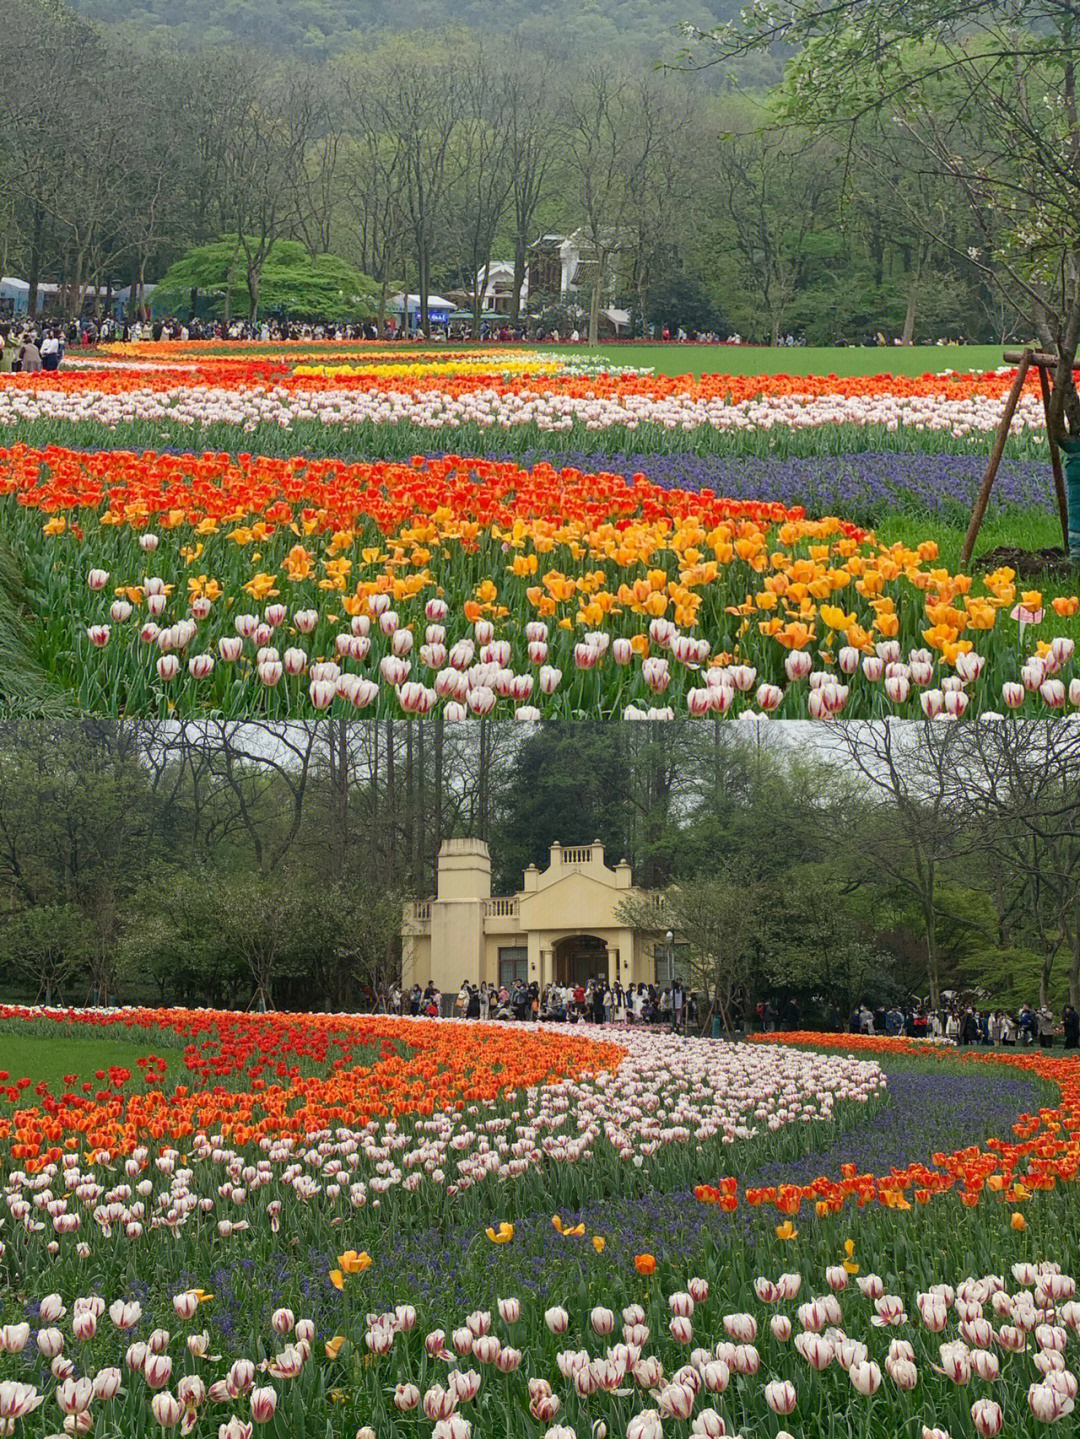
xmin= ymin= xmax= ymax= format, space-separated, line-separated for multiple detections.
xmin=390 ymin=976 xmax=696 ymax=1030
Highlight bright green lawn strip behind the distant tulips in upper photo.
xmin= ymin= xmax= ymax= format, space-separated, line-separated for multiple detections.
xmin=578 ymin=344 xmax=1004 ymax=376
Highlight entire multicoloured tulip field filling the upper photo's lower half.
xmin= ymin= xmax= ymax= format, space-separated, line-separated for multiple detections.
xmin=0 ymin=342 xmax=1080 ymax=721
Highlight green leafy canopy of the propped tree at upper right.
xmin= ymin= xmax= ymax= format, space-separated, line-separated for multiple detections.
xmin=686 ymin=0 xmax=1080 ymax=443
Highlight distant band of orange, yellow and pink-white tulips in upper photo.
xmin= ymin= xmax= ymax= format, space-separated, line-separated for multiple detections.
xmin=0 ymin=347 xmax=1064 ymax=456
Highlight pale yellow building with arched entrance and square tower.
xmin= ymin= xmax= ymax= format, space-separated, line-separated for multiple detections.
xmin=401 ymin=839 xmax=669 ymax=993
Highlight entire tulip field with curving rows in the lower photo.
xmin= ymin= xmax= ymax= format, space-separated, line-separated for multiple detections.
xmin=0 ymin=1006 xmax=1080 ymax=1439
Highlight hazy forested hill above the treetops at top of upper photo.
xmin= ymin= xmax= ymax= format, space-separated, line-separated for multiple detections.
xmin=72 ymin=0 xmax=738 ymax=59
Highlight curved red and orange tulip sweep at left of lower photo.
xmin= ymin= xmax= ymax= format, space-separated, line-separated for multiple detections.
xmin=0 ymin=1006 xmax=623 ymax=1173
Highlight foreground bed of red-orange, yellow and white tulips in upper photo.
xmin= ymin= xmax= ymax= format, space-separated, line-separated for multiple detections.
xmin=0 ymin=446 xmax=1080 ymax=720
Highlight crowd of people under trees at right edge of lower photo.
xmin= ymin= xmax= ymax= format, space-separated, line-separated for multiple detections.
xmin=847 ymin=1004 xmax=1080 ymax=1049
